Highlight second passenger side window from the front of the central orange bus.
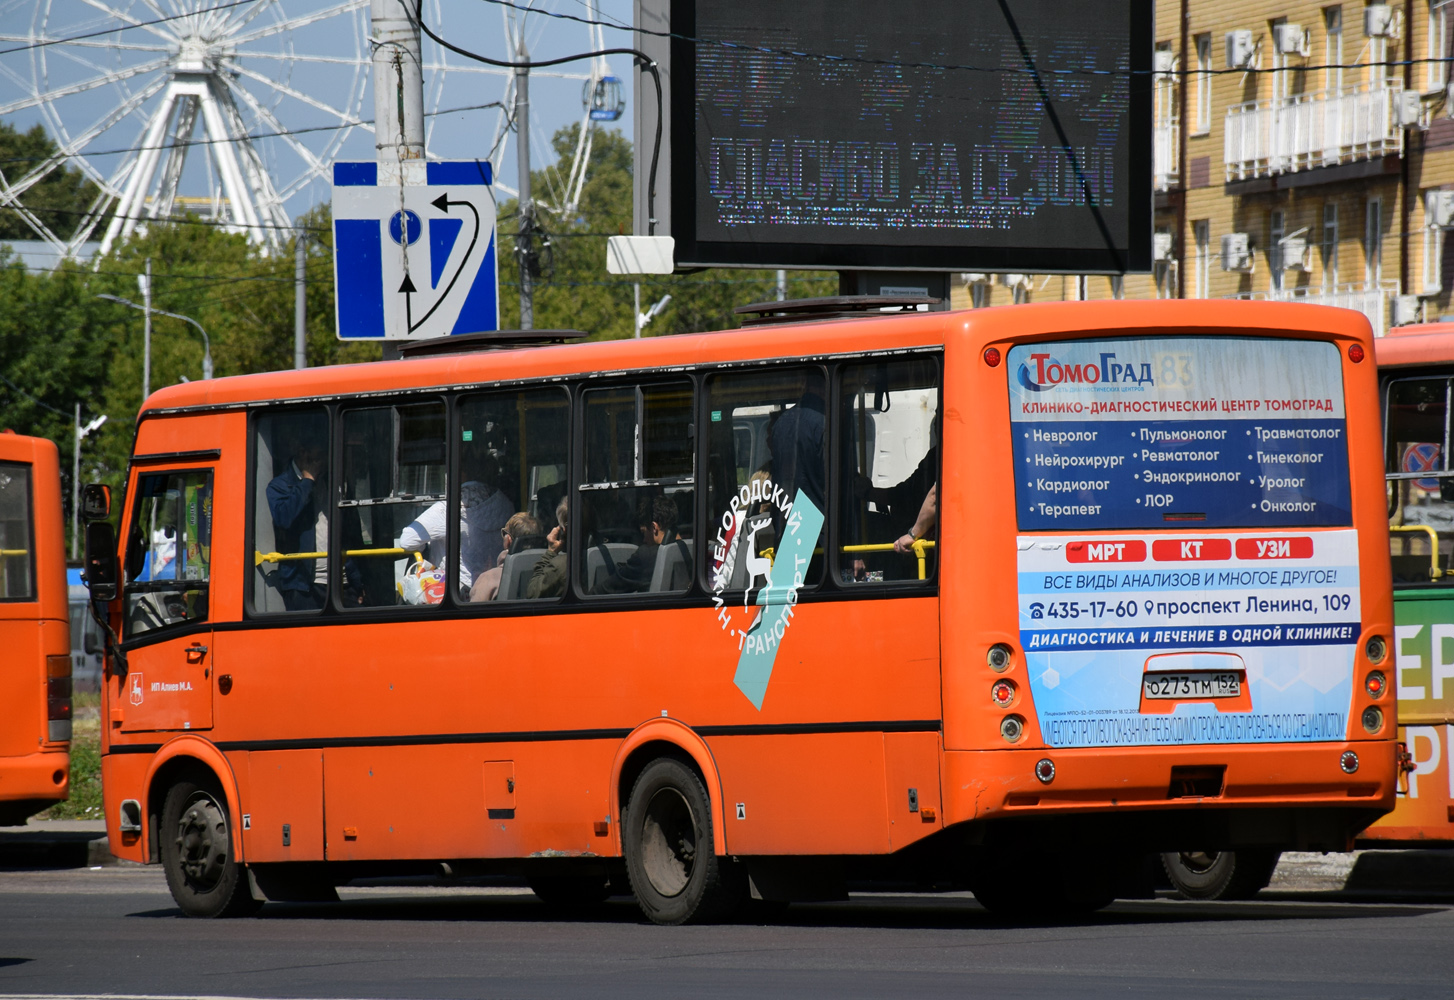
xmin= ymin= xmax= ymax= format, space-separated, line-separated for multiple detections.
xmin=333 ymin=401 xmax=451 ymax=608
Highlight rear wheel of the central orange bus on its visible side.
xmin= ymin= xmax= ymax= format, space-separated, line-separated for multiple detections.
xmin=622 ymin=757 xmax=747 ymax=924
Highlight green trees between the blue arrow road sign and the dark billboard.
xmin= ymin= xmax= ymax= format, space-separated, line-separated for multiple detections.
xmin=499 ymin=125 xmax=838 ymax=340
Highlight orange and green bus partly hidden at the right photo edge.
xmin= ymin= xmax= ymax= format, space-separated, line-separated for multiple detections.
xmin=1358 ymin=323 xmax=1454 ymax=847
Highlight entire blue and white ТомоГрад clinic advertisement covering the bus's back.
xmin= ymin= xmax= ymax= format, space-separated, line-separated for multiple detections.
xmin=1008 ymin=337 xmax=1361 ymax=747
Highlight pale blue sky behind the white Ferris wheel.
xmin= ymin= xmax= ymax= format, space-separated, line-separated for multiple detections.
xmin=0 ymin=0 xmax=634 ymax=235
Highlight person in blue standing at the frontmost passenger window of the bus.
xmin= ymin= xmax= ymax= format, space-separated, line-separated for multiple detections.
xmin=268 ymin=439 xmax=329 ymax=610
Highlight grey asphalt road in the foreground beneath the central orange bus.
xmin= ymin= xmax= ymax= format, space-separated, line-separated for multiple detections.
xmin=0 ymin=868 xmax=1454 ymax=1000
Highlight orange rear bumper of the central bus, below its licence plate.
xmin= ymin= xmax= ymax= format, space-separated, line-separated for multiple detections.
xmin=944 ymin=740 xmax=1397 ymax=836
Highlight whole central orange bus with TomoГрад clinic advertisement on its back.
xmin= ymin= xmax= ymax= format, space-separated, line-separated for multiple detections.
xmin=87 ymin=301 xmax=1396 ymax=923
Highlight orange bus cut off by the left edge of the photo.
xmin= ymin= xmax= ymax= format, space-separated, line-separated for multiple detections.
xmin=0 ymin=430 xmax=71 ymax=826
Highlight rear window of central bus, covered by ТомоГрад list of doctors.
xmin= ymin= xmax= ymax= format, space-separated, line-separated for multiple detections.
xmin=1006 ymin=337 xmax=1352 ymax=531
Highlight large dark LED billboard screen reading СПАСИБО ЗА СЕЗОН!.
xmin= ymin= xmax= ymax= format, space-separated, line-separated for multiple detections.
xmin=669 ymin=0 xmax=1153 ymax=273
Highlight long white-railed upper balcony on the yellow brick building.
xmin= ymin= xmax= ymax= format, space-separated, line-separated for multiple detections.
xmin=1223 ymin=80 xmax=1403 ymax=182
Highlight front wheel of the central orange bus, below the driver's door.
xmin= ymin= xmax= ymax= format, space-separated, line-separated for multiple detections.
xmin=158 ymin=779 xmax=262 ymax=917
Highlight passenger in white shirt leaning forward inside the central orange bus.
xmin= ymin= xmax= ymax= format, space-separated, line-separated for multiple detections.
xmin=395 ymin=446 xmax=515 ymax=594
